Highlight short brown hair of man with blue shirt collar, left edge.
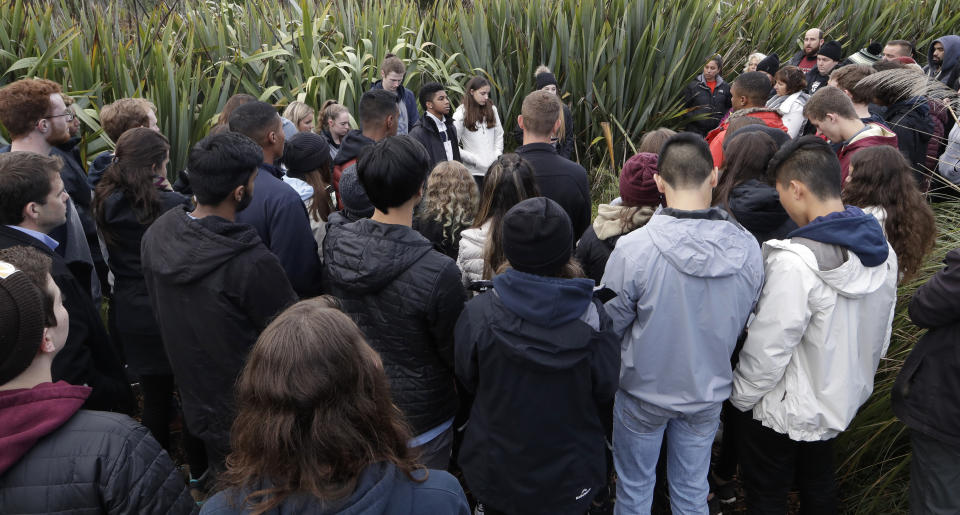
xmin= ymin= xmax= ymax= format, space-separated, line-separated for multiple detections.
xmin=0 ymin=152 xmax=63 ymax=225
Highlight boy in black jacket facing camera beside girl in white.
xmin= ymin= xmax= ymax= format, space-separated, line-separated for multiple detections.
xmin=410 ymin=82 xmax=461 ymax=170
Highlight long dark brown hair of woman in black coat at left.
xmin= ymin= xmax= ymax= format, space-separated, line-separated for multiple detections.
xmin=93 ymin=127 xmax=170 ymax=242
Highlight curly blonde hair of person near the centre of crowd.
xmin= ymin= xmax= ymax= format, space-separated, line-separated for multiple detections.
xmin=420 ymin=161 xmax=480 ymax=243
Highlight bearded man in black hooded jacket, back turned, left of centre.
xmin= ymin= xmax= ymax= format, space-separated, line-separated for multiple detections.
xmin=140 ymin=132 xmax=296 ymax=474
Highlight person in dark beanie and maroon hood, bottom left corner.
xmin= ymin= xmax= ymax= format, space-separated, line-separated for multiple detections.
xmin=0 ymin=246 xmax=196 ymax=514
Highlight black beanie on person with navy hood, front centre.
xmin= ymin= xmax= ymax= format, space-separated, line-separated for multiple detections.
xmin=503 ymin=197 xmax=573 ymax=276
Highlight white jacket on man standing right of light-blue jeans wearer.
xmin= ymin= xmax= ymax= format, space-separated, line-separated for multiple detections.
xmin=730 ymin=240 xmax=897 ymax=441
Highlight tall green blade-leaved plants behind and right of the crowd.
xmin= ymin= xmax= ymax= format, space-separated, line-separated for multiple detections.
xmin=0 ymin=0 xmax=960 ymax=513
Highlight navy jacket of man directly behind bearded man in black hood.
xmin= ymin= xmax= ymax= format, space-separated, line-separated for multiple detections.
xmin=237 ymin=164 xmax=320 ymax=298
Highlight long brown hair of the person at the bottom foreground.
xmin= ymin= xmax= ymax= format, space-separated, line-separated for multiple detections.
xmin=221 ymin=296 xmax=426 ymax=514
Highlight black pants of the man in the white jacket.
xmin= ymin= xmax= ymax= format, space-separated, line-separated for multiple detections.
xmin=738 ymin=418 xmax=837 ymax=515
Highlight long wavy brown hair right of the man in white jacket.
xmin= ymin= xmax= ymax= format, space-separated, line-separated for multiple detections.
xmin=843 ymin=145 xmax=937 ymax=281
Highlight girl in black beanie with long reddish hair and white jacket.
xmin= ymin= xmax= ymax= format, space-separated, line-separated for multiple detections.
xmin=283 ymin=132 xmax=336 ymax=259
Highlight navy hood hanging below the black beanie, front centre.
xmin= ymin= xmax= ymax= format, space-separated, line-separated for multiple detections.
xmin=493 ymin=269 xmax=594 ymax=328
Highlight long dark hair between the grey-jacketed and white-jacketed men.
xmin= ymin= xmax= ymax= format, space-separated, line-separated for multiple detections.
xmin=712 ymin=131 xmax=777 ymax=211
